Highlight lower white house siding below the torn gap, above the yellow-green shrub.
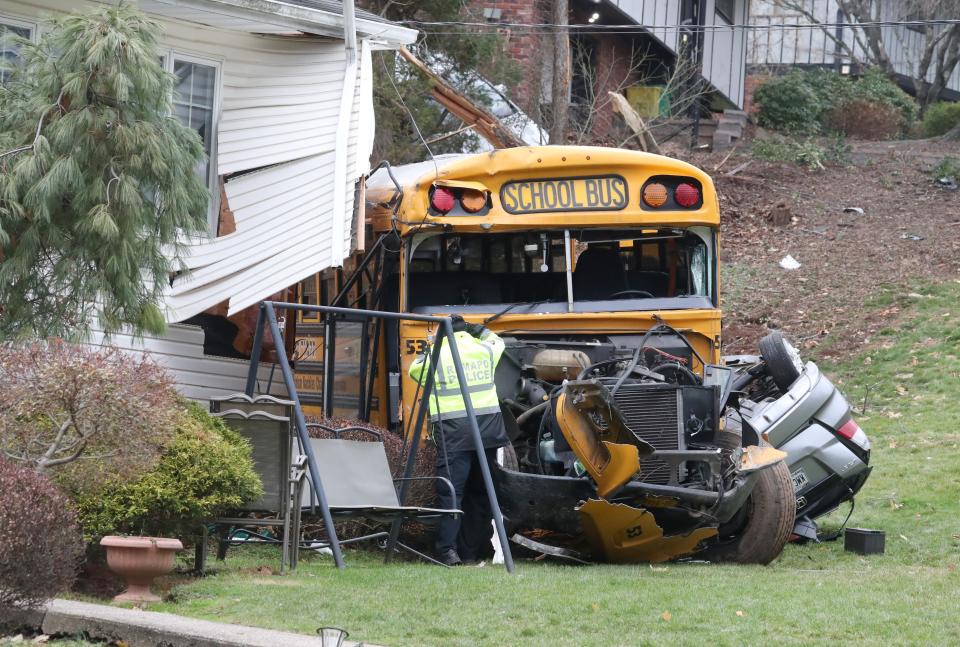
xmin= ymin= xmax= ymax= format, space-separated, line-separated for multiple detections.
xmin=90 ymin=324 xmax=286 ymax=402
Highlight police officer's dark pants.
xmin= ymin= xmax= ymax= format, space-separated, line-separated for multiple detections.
xmin=434 ymin=447 xmax=497 ymax=561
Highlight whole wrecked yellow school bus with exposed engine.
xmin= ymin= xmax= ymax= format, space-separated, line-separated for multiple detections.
xmin=304 ymin=146 xmax=795 ymax=562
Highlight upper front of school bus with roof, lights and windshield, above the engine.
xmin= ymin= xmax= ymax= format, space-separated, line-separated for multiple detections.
xmin=367 ymin=147 xmax=720 ymax=428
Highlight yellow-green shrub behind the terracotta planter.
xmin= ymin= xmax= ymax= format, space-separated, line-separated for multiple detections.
xmin=77 ymin=403 xmax=262 ymax=539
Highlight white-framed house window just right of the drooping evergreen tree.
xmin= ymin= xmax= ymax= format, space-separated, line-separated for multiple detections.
xmin=162 ymin=52 xmax=220 ymax=232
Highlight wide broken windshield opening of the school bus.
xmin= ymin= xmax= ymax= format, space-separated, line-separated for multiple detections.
xmin=408 ymin=229 xmax=712 ymax=308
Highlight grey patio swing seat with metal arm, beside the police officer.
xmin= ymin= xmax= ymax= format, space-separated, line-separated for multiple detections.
xmin=293 ymin=424 xmax=462 ymax=564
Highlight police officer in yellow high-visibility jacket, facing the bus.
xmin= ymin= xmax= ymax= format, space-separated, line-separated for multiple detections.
xmin=410 ymin=315 xmax=510 ymax=566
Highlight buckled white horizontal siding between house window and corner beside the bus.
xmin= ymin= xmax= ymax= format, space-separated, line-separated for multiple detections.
xmin=167 ymin=37 xmax=374 ymax=321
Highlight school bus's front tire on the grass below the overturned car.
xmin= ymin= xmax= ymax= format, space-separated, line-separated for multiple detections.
xmin=699 ymin=461 xmax=797 ymax=564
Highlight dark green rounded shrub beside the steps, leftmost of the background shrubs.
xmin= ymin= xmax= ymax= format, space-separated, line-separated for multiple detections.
xmin=753 ymin=72 xmax=822 ymax=133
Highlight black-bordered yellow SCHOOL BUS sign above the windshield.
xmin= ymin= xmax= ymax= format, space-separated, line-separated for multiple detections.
xmin=500 ymin=175 xmax=629 ymax=214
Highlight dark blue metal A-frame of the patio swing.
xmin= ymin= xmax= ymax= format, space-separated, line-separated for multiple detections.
xmin=246 ymin=301 xmax=514 ymax=573
